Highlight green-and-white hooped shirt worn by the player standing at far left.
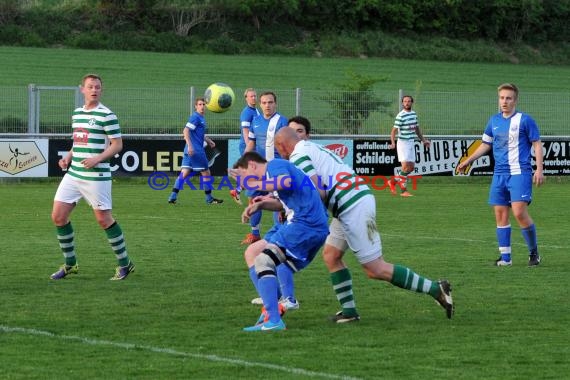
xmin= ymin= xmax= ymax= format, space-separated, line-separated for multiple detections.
xmin=68 ymin=103 xmax=121 ymax=181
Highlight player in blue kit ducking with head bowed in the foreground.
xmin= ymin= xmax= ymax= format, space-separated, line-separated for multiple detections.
xmin=230 ymin=152 xmax=329 ymax=331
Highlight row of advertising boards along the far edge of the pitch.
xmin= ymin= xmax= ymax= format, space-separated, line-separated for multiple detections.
xmin=0 ymin=137 xmax=570 ymax=178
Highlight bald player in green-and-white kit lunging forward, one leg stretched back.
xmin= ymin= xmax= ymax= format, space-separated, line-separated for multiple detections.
xmin=275 ymin=116 xmax=453 ymax=323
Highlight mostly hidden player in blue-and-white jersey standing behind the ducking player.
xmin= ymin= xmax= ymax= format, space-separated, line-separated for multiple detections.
xmin=242 ymin=91 xmax=287 ymax=244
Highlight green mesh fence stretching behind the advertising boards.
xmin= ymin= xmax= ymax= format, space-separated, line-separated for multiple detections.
xmin=0 ymin=85 xmax=570 ymax=136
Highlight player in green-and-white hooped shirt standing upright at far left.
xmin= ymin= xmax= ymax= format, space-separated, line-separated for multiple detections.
xmin=51 ymin=74 xmax=135 ymax=280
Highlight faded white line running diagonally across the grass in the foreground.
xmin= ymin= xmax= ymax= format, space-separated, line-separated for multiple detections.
xmin=0 ymin=325 xmax=360 ymax=380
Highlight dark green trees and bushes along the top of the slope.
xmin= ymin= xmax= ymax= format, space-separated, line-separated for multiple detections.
xmin=0 ymin=0 xmax=570 ymax=64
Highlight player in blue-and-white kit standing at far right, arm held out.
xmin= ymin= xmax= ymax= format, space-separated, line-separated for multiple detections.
xmin=457 ymin=83 xmax=544 ymax=267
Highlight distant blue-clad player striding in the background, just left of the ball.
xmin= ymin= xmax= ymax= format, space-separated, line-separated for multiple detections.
xmin=168 ymin=98 xmax=224 ymax=204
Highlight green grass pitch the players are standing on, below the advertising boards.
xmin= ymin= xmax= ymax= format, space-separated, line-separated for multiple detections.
xmin=0 ymin=178 xmax=570 ymax=379
